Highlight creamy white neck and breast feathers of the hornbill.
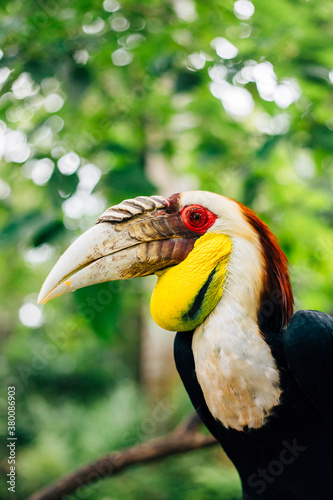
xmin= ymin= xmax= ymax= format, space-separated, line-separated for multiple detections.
xmin=192 ymin=236 xmax=281 ymax=430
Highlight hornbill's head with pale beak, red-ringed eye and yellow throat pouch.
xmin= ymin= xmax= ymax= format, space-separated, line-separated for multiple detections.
xmin=38 ymin=191 xmax=293 ymax=331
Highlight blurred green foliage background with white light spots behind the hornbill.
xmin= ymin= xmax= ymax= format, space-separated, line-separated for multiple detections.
xmin=0 ymin=0 xmax=333 ymax=500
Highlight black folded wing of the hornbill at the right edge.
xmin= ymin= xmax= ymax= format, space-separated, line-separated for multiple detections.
xmin=285 ymin=311 xmax=333 ymax=426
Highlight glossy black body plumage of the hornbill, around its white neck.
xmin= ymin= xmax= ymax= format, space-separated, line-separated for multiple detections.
xmin=174 ymin=311 xmax=333 ymax=500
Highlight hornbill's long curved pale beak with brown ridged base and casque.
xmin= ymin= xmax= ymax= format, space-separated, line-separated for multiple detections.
xmin=38 ymin=196 xmax=196 ymax=304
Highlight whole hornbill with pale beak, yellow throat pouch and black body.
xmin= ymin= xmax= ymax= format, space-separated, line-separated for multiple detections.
xmin=39 ymin=191 xmax=333 ymax=500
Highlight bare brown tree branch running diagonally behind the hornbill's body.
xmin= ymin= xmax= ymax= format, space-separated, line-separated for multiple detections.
xmin=28 ymin=414 xmax=217 ymax=500
